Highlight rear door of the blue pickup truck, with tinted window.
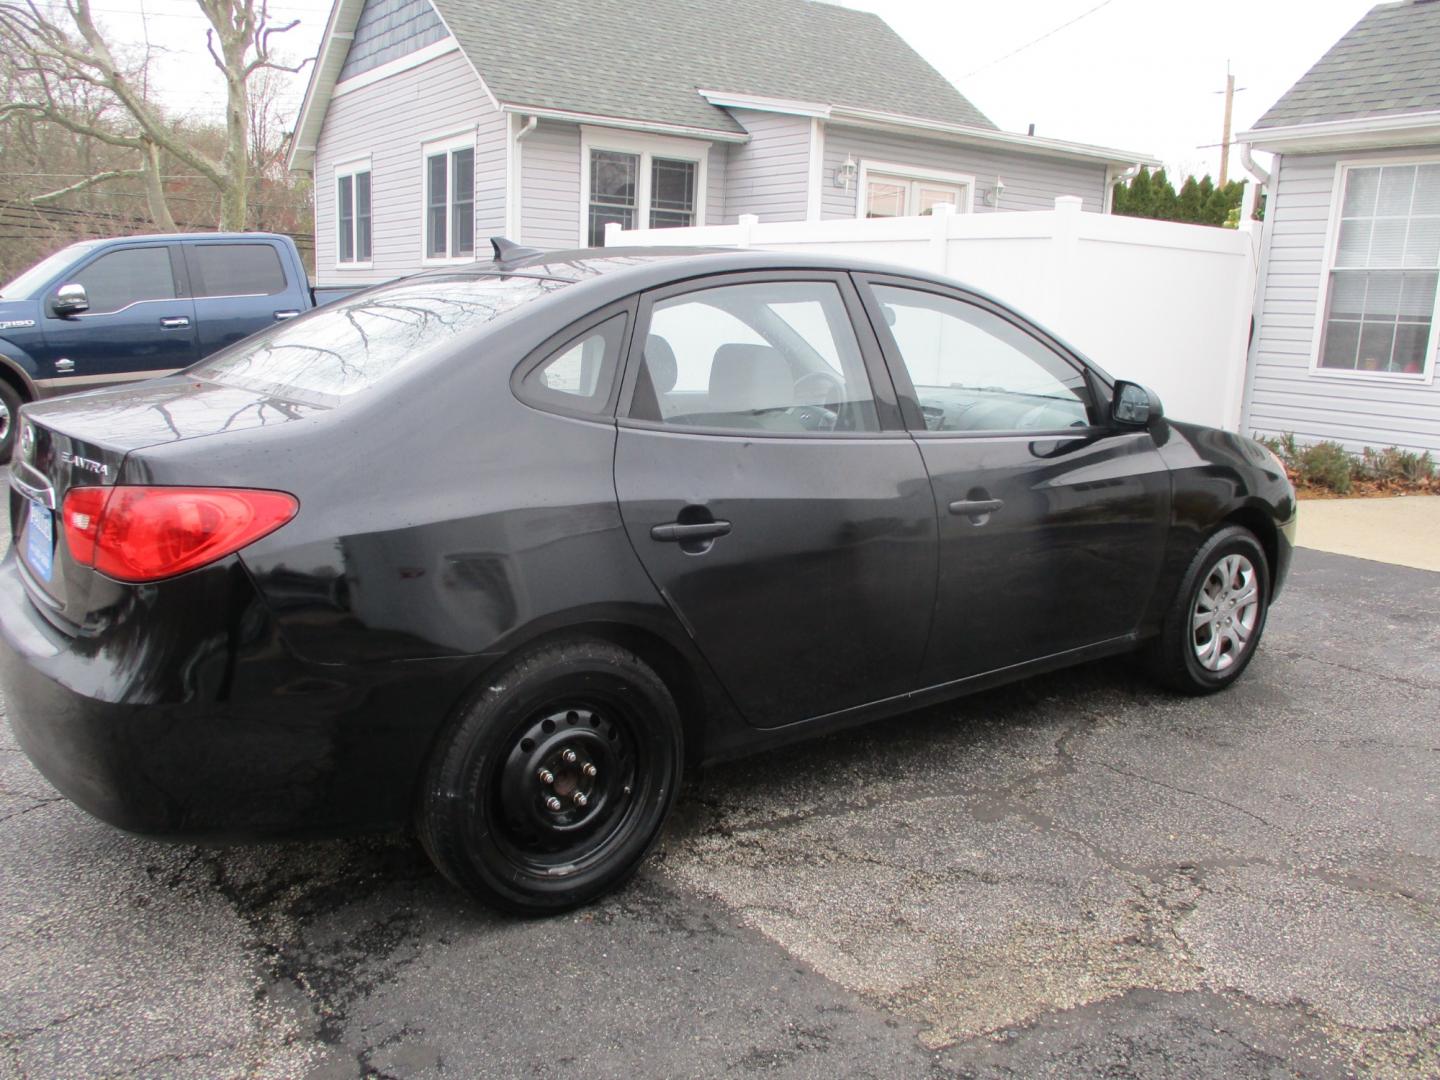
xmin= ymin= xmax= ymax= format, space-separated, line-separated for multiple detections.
xmin=184 ymin=240 xmax=302 ymax=357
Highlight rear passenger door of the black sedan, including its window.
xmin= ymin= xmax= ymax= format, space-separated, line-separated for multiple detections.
xmin=615 ymin=272 xmax=936 ymax=727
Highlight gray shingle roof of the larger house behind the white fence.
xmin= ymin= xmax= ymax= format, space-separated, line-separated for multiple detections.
xmin=432 ymin=0 xmax=995 ymax=132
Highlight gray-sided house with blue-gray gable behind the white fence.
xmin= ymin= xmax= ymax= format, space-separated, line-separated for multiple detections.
xmin=289 ymin=0 xmax=1156 ymax=285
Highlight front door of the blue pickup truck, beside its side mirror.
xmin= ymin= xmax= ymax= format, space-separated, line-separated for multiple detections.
xmin=42 ymin=243 xmax=199 ymax=392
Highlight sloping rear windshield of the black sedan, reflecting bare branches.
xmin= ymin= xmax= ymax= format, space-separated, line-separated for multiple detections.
xmin=190 ymin=276 xmax=570 ymax=405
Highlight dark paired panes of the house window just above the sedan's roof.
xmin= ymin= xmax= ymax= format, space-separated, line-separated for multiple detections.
xmin=585 ymin=147 xmax=700 ymax=248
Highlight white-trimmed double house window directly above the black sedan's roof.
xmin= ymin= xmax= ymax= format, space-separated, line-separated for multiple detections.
xmin=582 ymin=128 xmax=708 ymax=248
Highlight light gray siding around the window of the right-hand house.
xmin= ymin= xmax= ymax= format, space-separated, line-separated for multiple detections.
xmin=1243 ymin=147 xmax=1440 ymax=452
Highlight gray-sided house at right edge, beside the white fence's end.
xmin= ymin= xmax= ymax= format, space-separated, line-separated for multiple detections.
xmin=1238 ymin=0 xmax=1440 ymax=452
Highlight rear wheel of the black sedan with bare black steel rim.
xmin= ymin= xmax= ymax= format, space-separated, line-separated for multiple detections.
xmin=416 ymin=639 xmax=683 ymax=914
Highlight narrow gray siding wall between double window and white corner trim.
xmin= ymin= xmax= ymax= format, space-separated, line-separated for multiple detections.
xmin=723 ymin=109 xmax=811 ymax=225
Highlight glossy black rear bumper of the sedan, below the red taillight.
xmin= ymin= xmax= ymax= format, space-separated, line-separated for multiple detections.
xmin=0 ymin=554 xmax=478 ymax=840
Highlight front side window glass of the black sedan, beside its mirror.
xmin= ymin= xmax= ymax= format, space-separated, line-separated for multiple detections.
xmin=874 ymin=285 xmax=1090 ymax=432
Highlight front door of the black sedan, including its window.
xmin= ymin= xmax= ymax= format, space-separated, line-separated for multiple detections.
xmin=863 ymin=276 xmax=1171 ymax=683
